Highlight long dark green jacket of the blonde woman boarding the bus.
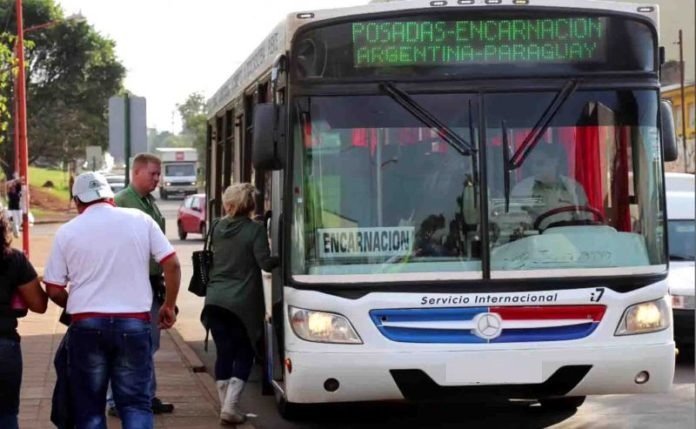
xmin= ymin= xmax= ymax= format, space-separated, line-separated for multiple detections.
xmin=203 ymin=216 xmax=278 ymax=347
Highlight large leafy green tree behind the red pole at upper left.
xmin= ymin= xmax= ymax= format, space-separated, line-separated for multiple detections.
xmin=0 ymin=0 xmax=125 ymax=177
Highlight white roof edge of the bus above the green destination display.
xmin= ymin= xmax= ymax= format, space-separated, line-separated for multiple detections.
xmin=206 ymin=0 xmax=659 ymax=118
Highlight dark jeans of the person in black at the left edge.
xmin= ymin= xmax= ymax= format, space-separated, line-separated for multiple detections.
xmin=0 ymin=338 xmax=22 ymax=429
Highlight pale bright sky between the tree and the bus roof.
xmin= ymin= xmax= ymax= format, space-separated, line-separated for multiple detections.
xmin=56 ymin=0 xmax=367 ymax=133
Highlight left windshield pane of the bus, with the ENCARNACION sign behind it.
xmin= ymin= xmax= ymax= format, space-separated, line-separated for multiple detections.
xmin=293 ymin=94 xmax=481 ymax=278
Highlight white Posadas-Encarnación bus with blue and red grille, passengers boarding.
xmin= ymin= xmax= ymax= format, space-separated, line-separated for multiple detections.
xmin=206 ymin=0 xmax=676 ymax=415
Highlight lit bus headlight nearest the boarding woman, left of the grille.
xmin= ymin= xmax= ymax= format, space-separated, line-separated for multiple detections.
xmin=289 ymin=307 xmax=362 ymax=344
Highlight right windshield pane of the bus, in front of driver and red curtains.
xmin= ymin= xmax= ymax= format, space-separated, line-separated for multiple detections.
xmin=485 ymin=90 xmax=665 ymax=278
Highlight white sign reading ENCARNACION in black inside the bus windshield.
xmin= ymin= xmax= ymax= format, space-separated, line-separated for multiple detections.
xmin=317 ymin=227 xmax=414 ymax=258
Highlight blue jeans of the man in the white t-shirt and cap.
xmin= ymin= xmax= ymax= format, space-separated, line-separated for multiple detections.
xmin=68 ymin=317 xmax=153 ymax=429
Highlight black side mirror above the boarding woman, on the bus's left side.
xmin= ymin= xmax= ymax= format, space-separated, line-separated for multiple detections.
xmin=251 ymin=103 xmax=285 ymax=170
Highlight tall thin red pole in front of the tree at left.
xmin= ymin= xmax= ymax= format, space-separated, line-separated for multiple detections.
xmin=15 ymin=0 xmax=30 ymax=258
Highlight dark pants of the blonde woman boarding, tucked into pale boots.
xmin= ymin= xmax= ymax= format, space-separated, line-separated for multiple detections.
xmin=205 ymin=305 xmax=254 ymax=381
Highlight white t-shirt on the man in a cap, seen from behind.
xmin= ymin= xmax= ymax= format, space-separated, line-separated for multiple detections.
xmin=44 ymin=203 xmax=175 ymax=314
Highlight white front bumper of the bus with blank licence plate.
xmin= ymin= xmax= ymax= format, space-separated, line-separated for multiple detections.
xmin=285 ymin=343 xmax=674 ymax=403
